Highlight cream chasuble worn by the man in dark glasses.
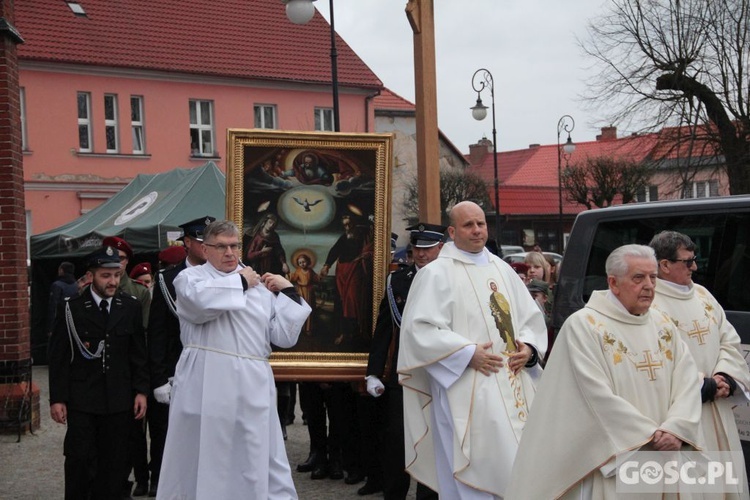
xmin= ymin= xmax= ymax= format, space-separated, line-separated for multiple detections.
xmin=652 ymin=279 xmax=750 ymax=499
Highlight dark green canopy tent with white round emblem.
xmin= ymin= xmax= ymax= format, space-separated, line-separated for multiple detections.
xmin=31 ymin=162 xmax=226 ymax=363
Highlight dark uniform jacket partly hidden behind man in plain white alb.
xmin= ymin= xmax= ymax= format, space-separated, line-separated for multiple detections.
xmin=148 ymin=261 xmax=187 ymax=389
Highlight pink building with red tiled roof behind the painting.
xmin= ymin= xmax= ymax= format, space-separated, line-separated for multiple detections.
xmin=15 ymin=0 xmax=383 ymax=234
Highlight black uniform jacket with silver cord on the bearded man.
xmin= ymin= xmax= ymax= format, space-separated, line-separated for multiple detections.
xmin=49 ymin=287 xmax=149 ymax=415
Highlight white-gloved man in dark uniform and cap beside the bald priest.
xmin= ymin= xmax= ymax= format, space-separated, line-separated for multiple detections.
xmin=361 ymin=223 xmax=447 ymax=500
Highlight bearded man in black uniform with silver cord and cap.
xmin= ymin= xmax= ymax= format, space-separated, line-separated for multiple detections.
xmin=49 ymin=247 xmax=149 ymax=500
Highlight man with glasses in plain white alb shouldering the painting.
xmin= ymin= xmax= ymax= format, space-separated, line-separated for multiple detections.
xmin=157 ymin=221 xmax=310 ymax=500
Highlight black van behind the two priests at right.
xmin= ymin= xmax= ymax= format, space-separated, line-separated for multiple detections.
xmin=552 ymin=195 xmax=750 ymax=344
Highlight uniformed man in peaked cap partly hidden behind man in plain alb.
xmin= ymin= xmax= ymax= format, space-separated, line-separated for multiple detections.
xmin=148 ymin=216 xmax=216 ymax=496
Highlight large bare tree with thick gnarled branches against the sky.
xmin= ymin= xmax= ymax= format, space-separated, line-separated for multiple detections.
xmin=581 ymin=0 xmax=750 ymax=194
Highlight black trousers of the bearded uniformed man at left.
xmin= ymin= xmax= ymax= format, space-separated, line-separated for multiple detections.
xmin=63 ymin=409 xmax=133 ymax=500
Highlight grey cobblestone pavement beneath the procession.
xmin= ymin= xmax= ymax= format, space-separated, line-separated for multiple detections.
xmin=0 ymin=366 xmax=415 ymax=500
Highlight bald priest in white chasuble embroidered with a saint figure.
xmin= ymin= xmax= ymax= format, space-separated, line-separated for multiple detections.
xmin=398 ymin=201 xmax=547 ymax=499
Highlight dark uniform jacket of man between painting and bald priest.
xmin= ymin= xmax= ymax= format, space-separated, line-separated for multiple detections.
xmin=367 ymin=265 xmax=417 ymax=386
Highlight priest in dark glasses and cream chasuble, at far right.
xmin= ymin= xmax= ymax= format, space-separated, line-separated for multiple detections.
xmin=649 ymin=231 xmax=750 ymax=499
